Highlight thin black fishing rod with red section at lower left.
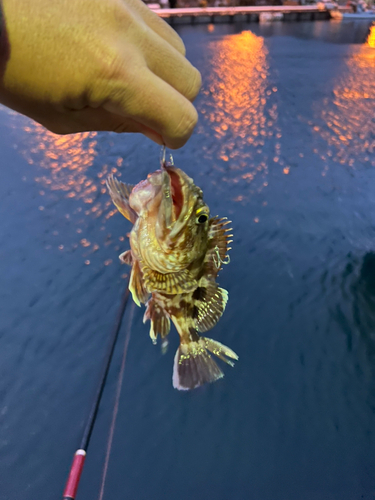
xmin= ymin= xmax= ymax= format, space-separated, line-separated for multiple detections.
xmin=62 ymin=279 xmax=129 ymax=500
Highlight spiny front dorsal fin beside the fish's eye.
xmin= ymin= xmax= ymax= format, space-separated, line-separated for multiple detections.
xmin=204 ymin=217 xmax=233 ymax=278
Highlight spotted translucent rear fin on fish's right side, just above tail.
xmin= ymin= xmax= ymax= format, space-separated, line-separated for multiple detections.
xmin=193 ymin=277 xmax=228 ymax=332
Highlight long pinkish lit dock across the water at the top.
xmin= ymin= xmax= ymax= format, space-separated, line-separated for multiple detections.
xmin=154 ymin=5 xmax=331 ymax=24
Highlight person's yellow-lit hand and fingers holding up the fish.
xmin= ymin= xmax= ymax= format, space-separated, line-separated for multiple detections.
xmin=0 ymin=0 xmax=201 ymax=149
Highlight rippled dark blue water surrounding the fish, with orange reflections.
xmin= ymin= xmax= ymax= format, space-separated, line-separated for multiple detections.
xmin=0 ymin=22 xmax=375 ymax=500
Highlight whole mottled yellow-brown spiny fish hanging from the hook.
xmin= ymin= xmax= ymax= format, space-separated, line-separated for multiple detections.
xmin=107 ymin=161 xmax=238 ymax=390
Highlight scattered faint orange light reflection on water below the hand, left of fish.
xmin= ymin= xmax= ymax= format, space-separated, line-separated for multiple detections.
xmin=21 ymin=122 xmax=122 ymax=265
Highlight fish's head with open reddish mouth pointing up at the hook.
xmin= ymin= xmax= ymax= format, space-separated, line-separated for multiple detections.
xmin=129 ymin=166 xmax=210 ymax=254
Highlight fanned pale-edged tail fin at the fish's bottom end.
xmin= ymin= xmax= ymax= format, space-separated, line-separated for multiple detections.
xmin=173 ymin=337 xmax=238 ymax=390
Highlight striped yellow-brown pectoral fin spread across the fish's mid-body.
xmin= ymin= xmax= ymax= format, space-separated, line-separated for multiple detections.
xmin=143 ymin=266 xmax=197 ymax=295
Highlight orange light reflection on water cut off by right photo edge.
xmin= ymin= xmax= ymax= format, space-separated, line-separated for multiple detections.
xmin=310 ymin=26 xmax=375 ymax=170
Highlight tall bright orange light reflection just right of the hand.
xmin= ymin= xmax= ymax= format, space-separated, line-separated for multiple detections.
xmin=198 ymin=31 xmax=282 ymax=201
